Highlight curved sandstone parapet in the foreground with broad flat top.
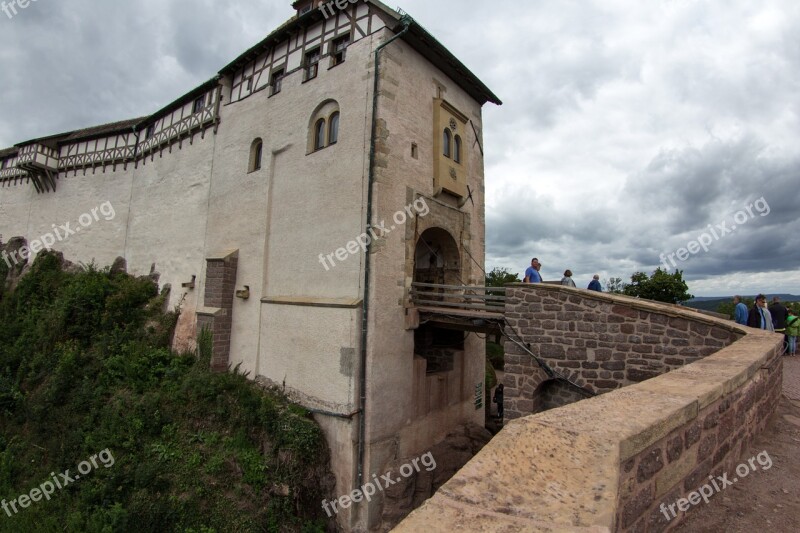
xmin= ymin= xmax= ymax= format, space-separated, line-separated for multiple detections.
xmin=395 ymin=290 xmax=783 ymax=532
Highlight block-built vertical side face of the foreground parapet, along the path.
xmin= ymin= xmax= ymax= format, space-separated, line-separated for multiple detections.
xmin=616 ymin=336 xmax=782 ymax=531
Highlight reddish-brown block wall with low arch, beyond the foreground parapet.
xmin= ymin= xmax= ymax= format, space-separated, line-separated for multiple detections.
xmin=504 ymin=284 xmax=742 ymax=419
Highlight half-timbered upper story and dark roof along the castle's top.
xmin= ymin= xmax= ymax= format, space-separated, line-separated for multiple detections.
xmin=0 ymin=0 xmax=500 ymax=193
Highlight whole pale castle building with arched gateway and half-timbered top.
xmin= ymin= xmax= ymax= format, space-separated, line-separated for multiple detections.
xmin=0 ymin=0 xmax=501 ymax=530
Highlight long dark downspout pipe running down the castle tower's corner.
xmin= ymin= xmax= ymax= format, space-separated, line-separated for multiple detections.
xmin=355 ymin=15 xmax=413 ymax=487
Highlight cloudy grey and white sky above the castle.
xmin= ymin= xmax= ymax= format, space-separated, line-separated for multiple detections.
xmin=0 ymin=0 xmax=800 ymax=296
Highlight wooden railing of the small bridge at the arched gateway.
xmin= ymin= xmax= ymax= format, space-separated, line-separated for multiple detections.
xmin=409 ymin=282 xmax=506 ymax=313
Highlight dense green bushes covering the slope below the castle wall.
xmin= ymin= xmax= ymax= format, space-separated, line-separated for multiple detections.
xmin=0 ymin=253 xmax=332 ymax=533
